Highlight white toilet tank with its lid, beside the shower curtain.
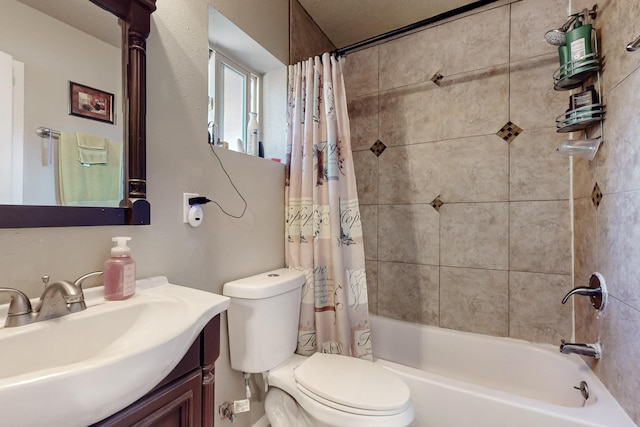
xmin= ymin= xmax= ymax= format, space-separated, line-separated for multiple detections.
xmin=222 ymin=268 xmax=305 ymax=373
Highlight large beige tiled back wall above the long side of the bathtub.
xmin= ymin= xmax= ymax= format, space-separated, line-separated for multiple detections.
xmin=345 ymin=0 xmax=573 ymax=344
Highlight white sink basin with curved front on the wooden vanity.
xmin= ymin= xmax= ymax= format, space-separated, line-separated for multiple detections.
xmin=0 ymin=277 xmax=229 ymax=427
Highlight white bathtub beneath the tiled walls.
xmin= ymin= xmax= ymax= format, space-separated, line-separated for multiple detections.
xmin=371 ymin=316 xmax=636 ymax=427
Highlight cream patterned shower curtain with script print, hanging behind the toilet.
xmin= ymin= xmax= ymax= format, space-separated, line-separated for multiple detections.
xmin=285 ymin=53 xmax=371 ymax=359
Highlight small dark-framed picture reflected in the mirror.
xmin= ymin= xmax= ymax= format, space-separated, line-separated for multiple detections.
xmin=69 ymin=82 xmax=113 ymax=124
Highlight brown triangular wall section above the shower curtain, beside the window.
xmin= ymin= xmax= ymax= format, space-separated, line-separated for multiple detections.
xmin=289 ymin=0 xmax=336 ymax=64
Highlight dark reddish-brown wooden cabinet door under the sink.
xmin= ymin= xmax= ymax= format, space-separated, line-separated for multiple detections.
xmin=95 ymin=370 xmax=202 ymax=427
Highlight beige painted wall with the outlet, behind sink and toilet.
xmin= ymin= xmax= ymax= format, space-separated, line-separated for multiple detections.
xmin=0 ymin=0 xmax=288 ymax=426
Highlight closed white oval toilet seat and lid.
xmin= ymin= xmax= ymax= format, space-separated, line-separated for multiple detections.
xmin=294 ymin=353 xmax=411 ymax=416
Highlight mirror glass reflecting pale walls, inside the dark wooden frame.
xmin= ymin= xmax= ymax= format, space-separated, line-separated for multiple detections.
xmin=0 ymin=0 xmax=124 ymax=206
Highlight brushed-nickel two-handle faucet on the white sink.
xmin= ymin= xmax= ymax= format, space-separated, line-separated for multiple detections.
xmin=0 ymin=271 xmax=102 ymax=328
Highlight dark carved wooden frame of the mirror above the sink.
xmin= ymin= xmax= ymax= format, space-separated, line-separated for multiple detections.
xmin=0 ymin=0 xmax=156 ymax=228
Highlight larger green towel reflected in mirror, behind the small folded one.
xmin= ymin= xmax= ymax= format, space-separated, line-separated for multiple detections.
xmin=58 ymin=132 xmax=123 ymax=207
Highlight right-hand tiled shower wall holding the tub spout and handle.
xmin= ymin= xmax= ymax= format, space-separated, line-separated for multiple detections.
xmin=573 ymin=0 xmax=640 ymax=424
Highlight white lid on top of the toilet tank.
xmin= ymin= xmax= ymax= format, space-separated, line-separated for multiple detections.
xmin=222 ymin=268 xmax=305 ymax=299
